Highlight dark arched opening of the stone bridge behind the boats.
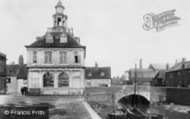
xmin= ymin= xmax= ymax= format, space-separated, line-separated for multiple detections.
xmin=118 ymin=94 xmax=150 ymax=112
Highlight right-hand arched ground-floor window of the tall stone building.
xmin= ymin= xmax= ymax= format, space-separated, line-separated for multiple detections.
xmin=58 ymin=72 xmax=69 ymax=87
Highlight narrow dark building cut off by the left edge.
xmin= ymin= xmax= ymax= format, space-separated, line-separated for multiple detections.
xmin=0 ymin=53 xmax=6 ymax=94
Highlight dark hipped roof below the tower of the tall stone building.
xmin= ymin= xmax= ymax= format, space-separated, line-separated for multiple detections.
xmin=25 ymin=32 xmax=86 ymax=49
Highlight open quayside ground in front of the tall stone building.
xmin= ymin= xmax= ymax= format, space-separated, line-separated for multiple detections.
xmin=0 ymin=95 xmax=93 ymax=119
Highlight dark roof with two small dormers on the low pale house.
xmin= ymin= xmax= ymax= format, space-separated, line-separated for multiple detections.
xmin=85 ymin=67 xmax=111 ymax=79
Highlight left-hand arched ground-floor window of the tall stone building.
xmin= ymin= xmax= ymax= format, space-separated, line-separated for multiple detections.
xmin=43 ymin=72 xmax=54 ymax=87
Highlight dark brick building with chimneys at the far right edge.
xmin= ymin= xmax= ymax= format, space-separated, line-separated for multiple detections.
xmin=166 ymin=59 xmax=190 ymax=87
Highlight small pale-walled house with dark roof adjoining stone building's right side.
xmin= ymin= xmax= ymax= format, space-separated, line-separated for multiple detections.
xmin=85 ymin=63 xmax=111 ymax=87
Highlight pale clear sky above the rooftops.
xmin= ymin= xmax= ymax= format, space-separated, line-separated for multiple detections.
xmin=0 ymin=0 xmax=190 ymax=77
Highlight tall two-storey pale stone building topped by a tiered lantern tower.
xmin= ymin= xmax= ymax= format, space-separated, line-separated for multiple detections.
xmin=26 ymin=1 xmax=86 ymax=95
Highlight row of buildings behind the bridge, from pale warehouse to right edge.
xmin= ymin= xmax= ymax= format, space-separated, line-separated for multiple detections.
xmin=127 ymin=58 xmax=190 ymax=87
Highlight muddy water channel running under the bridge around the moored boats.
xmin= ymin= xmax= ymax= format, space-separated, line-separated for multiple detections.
xmin=100 ymin=95 xmax=190 ymax=119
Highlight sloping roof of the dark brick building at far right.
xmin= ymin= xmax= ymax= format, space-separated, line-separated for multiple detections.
xmin=167 ymin=61 xmax=190 ymax=72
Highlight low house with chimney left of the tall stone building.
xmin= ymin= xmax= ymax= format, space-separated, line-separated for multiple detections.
xmin=6 ymin=55 xmax=27 ymax=94
